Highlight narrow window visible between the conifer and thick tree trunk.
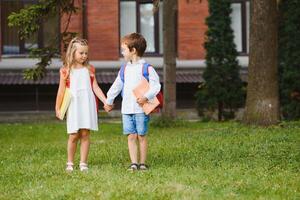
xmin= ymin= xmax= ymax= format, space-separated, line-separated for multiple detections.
xmin=231 ymin=0 xmax=250 ymax=55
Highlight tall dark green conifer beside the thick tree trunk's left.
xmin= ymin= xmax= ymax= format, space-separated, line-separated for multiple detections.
xmin=196 ymin=0 xmax=244 ymax=121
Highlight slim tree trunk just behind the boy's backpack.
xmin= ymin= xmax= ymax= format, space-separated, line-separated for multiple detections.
xmin=162 ymin=0 xmax=178 ymax=119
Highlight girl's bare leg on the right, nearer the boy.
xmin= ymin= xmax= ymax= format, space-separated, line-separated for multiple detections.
xmin=80 ymin=129 xmax=90 ymax=163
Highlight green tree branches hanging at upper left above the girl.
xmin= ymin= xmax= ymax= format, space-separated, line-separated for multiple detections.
xmin=8 ymin=0 xmax=79 ymax=80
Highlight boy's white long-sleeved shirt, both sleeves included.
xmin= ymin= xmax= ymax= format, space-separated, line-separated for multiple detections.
xmin=106 ymin=59 xmax=161 ymax=114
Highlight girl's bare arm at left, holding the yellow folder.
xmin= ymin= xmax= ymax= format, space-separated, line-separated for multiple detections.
xmin=55 ymin=68 xmax=68 ymax=117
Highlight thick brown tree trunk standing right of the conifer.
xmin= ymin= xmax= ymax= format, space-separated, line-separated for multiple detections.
xmin=244 ymin=0 xmax=279 ymax=125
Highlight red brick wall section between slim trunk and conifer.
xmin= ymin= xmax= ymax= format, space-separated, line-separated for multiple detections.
xmin=178 ymin=0 xmax=208 ymax=59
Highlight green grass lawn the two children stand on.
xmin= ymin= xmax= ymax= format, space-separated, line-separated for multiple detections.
xmin=0 ymin=122 xmax=300 ymax=200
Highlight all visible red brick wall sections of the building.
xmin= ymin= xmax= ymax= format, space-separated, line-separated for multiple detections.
xmin=61 ymin=0 xmax=208 ymax=60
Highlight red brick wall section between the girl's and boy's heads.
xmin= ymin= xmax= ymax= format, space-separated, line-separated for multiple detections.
xmin=87 ymin=0 xmax=119 ymax=60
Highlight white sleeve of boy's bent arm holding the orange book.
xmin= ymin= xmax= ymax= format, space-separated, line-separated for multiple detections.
xmin=144 ymin=67 xmax=161 ymax=100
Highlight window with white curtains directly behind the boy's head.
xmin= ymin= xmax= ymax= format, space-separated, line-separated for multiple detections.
xmin=120 ymin=0 xmax=163 ymax=55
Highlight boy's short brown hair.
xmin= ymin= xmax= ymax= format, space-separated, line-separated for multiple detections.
xmin=121 ymin=33 xmax=147 ymax=57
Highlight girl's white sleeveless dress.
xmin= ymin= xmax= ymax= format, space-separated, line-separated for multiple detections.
xmin=67 ymin=67 xmax=98 ymax=134
